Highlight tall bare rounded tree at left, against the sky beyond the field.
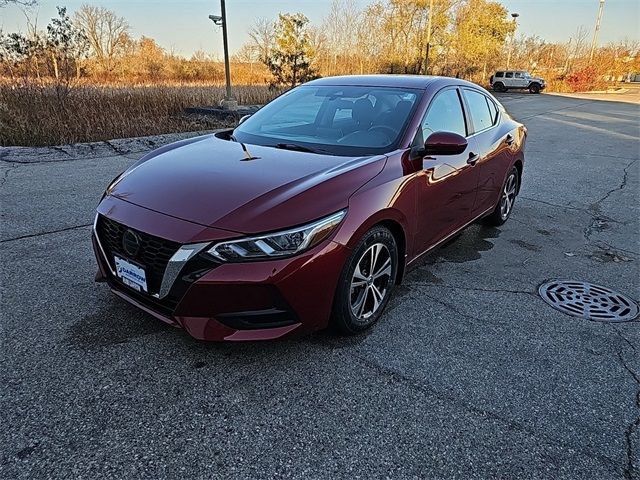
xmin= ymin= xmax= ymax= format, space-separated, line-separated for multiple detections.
xmin=75 ymin=5 xmax=130 ymax=75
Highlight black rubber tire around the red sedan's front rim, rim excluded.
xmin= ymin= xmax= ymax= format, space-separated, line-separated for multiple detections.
xmin=332 ymin=226 xmax=398 ymax=335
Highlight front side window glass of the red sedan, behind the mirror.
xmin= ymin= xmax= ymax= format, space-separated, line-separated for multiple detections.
xmin=415 ymin=89 xmax=467 ymax=144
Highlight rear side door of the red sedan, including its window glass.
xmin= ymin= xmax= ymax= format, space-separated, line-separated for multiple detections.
xmin=462 ymin=88 xmax=513 ymax=217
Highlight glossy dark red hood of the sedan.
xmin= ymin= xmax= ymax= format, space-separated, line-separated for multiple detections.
xmin=107 ymin=135 xmax=386 ymax=233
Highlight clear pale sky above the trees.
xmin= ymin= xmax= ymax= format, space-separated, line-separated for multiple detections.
xmin=0 ymin=0 xmax=640 ymax=56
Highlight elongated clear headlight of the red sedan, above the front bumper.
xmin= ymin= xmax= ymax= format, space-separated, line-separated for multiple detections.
xmin=208 ymin=210 xmax=347 ymax=262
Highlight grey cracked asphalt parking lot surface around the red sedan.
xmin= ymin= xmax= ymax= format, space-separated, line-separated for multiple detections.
xmin=0 ymin=93 xmax=640 ymax=479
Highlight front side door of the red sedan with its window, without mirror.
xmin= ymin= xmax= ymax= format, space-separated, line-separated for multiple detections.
xmin=414 ymin=88 xmax=479 ymax=252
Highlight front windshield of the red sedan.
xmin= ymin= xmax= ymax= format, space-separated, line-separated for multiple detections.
xmin=233 ymin=85 xmax=422 ymax=156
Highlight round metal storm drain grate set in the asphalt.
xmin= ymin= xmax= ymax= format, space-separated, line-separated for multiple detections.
xmin=538 ymin=280 xmax=638 ymax=322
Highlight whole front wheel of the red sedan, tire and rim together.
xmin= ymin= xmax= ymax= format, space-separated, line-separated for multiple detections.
xmin=332 ymin=226 xmax=398 ymax=335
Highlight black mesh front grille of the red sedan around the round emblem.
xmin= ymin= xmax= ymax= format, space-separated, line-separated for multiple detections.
xmin=96 ymin=215 xmax=180 ymax=294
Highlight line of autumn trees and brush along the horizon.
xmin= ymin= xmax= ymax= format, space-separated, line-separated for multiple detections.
xmin=0 ymin=0 xmax=640 ymax=90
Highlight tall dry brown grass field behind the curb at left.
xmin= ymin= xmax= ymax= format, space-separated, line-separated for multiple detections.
xmin=0 ymin=83 xmax=276 ymax=146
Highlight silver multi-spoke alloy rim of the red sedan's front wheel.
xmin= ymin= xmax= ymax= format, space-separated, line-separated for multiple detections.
xmin=350 ymin=243 xmax=393 ymax=322
